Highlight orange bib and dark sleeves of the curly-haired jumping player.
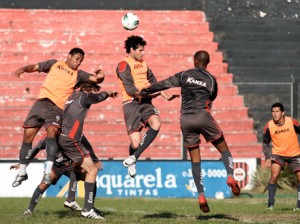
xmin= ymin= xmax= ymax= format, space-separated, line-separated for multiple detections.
xmin=117 ymin=57 xmax=156 ymax=101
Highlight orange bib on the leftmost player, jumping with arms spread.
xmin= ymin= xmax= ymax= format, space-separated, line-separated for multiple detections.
xmin=38 ymin=61 xmax=78 ymax=109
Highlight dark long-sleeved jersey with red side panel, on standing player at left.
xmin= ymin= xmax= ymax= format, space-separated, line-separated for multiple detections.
xmin=62 ymin=91 xmax=109 ymax=141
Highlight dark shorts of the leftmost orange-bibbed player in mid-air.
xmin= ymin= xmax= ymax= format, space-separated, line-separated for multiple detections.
xmin=23 ymin=98 xmax=63 ymax=129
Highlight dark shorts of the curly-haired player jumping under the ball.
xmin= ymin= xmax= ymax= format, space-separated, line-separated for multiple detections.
xmin=123 ymin=99 xmax=159 ymax=134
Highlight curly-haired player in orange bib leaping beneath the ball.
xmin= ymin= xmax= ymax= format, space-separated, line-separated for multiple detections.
xmin=116 ymin=36 xmax=178 ymax=178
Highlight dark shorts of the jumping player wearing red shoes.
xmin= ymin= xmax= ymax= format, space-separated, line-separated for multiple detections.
xmin=180 ymin=110 xmax=223 ymax=148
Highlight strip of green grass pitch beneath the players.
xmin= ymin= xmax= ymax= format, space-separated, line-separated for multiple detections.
xmin=0 ymin=194 xmax=300 ymax=224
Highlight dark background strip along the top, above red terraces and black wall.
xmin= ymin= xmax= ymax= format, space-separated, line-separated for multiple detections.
xmin=0 ymin=0 xmax=300 ymax=20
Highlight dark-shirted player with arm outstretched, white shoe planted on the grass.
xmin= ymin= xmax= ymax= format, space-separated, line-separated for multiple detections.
xmin=58 ymin=82 xmax=117 ymax=219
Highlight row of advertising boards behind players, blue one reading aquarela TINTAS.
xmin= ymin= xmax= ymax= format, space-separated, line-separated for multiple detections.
xmin=0 ymin=159 xmax=256 ymax=198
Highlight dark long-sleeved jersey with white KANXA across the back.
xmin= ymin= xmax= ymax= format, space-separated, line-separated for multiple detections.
xmin=141 ymin=68 xmax=218 ymax=114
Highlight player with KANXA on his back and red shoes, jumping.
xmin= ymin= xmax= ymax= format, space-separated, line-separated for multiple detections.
xmin=140 ymin=51 xmax=240 ymax=212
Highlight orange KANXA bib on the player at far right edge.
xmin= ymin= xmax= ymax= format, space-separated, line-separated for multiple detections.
xmin=265 ymin=116 xmax=300 ymax=157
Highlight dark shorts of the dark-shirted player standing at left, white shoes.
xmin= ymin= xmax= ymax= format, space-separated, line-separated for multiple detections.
xmin=58 ymin=134 xmax=90 ymax=166
